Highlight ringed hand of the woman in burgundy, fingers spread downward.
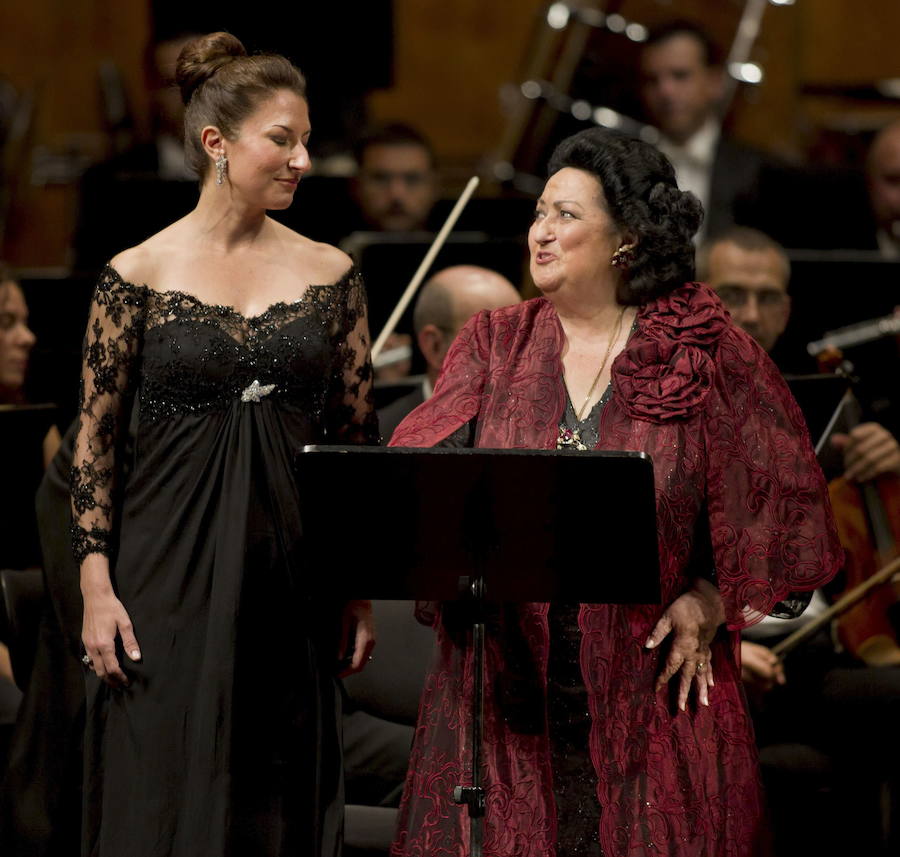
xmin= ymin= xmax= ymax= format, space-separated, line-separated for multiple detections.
xmin=644 ymin=578 xmax=725 ymax=711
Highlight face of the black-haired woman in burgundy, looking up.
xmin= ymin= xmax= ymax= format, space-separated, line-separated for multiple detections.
xmin=528 ymin=167 xmax=624 ymax=299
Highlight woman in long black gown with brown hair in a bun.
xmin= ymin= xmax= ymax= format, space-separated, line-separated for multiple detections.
xmin=72 ymin=33 xmax=377 ymax=857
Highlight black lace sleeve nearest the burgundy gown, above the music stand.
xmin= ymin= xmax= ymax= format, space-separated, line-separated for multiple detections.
xmin=326 ymin=270 xmax=380 ymax=445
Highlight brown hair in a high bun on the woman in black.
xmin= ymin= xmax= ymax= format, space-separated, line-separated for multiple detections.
xmin=175 ymin=33 xmax=306 ymax=181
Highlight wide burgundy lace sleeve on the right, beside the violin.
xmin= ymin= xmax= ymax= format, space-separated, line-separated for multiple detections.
xmin=703 ymin=330 xmax=843 ymax=629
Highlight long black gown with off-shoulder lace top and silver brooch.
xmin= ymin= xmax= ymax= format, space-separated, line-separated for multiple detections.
xmin=72 ymin=268 xmax=377 ymax=857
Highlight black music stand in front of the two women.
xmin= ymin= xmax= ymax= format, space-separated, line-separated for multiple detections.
xmin=296 ymin=446 xmax=660 ymax=857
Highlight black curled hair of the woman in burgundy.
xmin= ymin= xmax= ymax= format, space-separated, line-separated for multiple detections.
xmin=548 ymin=128 xmax=703 ymax=305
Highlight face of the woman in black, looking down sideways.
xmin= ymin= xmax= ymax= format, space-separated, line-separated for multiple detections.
xmin=212 ymin=89 xmax=311 ymax=209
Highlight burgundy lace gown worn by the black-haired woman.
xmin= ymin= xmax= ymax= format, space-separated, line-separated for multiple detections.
xmin=392 ymin=284 xmax=842 ymax=857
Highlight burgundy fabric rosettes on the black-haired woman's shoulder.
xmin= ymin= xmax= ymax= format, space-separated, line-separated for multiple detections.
xmin=612 ymin=283 xmax=731 ymax=423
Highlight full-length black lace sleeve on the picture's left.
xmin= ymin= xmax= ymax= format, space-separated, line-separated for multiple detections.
xmin=70 ymin=268 xmax=146 ymax=564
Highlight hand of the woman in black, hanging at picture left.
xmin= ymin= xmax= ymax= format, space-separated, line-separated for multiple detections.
xmin=81 ymin=554 xmax=141 ymax=687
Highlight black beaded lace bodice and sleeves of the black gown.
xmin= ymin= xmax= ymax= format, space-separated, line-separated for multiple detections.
xmin=71 ymin=267 xmax=377 ymax=562
